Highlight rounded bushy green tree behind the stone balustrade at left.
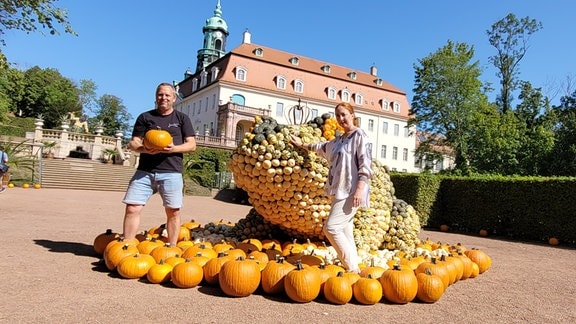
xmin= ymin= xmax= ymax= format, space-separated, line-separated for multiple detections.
xmin=17 ymin=66 xmax=82 ymax=128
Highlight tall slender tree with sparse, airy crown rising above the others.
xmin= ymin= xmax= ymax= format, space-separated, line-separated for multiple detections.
xmin=486 ymin=13 xmax=542 ymax=112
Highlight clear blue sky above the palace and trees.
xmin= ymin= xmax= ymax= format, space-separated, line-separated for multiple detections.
xmin=2 ymin=0 xmax=576 ymax=123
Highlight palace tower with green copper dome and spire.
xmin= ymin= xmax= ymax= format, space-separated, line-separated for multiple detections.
xmin=196 ymin=0 xmax=229 ymax=72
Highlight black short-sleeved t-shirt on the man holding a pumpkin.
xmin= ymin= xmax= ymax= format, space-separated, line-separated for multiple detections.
xmin=132 ymin=109 xmax=194 ymax=173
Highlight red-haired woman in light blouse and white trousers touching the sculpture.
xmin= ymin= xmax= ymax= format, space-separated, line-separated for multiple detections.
xmin=290 ymin=103 xmax=372 ymax=273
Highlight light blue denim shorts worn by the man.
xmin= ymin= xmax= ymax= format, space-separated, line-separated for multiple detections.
xmin=122 ymin=170 xmax=184 ymax=209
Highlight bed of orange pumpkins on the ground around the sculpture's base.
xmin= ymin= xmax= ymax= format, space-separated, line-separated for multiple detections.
xmin=93 ymin=222 xmax=491 ymax=305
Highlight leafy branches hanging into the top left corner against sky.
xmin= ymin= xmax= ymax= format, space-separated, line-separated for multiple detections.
xmin=0 ymin=0 xmax=76 ymax=45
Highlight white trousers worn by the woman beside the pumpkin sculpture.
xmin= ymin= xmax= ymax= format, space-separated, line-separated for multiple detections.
xmin=323 ymin=196 xmax=360 ymax=272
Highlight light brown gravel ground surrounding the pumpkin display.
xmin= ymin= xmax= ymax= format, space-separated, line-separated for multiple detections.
xmin=0 ymin=188 xmax=576 ymax=323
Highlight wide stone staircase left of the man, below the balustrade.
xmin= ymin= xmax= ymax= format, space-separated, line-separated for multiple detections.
xmin=42 ymin=158 xmax=135 ymax=191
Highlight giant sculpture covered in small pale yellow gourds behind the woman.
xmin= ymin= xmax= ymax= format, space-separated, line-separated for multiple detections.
xmin=228 ymin=115 xmax=420 ymax=251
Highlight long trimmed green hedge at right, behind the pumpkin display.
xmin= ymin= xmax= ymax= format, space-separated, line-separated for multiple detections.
xmin=391 ymin=174 xmax=576 ymax=245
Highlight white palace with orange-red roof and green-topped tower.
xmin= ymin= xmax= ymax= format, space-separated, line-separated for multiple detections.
xmin=174 ymin=0 xmax=420 ymax=172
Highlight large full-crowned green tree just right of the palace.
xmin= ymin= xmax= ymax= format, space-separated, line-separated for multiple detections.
xmin=408 ymin=41 xmax=488 ymax=174
